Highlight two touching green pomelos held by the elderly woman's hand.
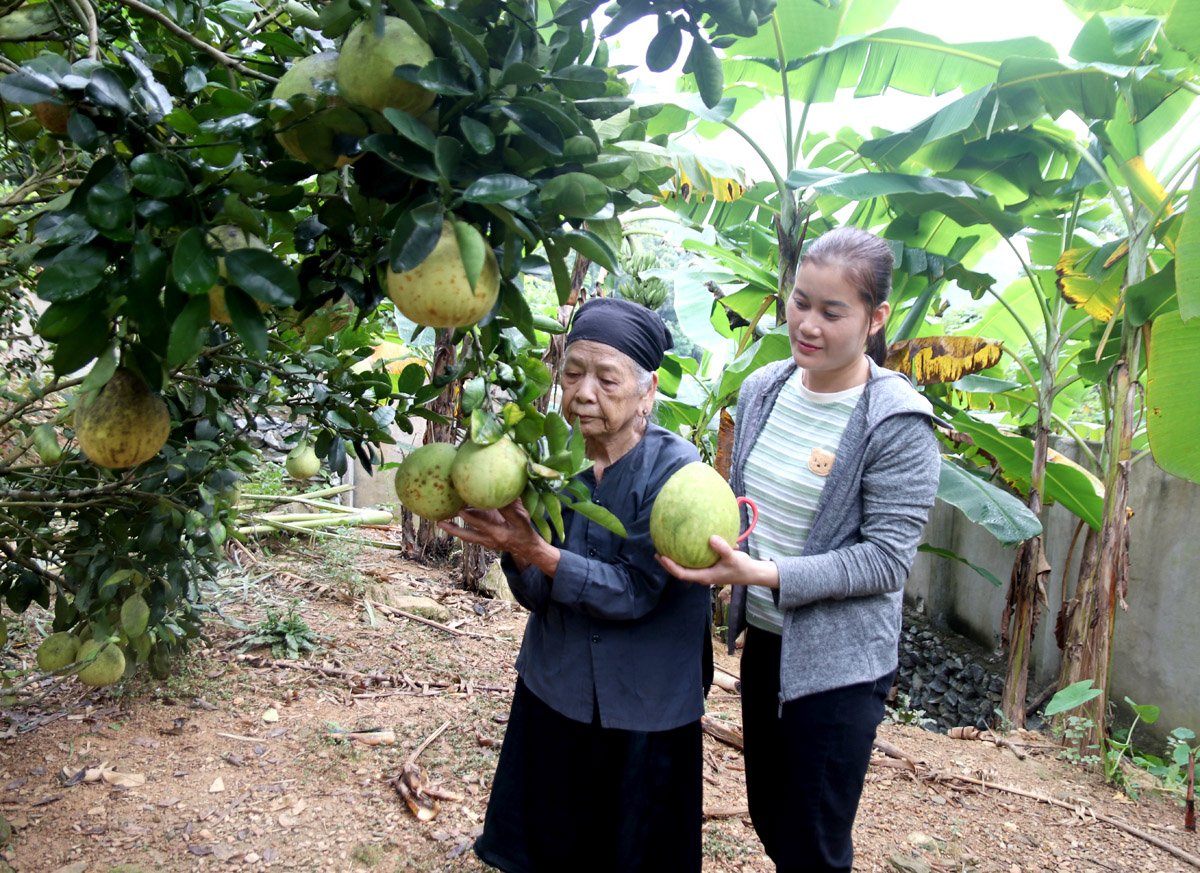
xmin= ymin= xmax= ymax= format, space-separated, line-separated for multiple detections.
xmin=396 ymin=437 xmax=528 ymax=520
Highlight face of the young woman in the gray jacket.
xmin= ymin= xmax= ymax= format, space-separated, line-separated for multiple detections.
xmin=787 ymin=263 xmax=888 ymax=392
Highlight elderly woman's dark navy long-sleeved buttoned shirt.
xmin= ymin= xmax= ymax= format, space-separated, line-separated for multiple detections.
xmin=502 ymin=425 xmax=710 ymax=730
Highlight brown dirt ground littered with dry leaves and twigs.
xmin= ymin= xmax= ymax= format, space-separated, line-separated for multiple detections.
xmin=0 ymin=534 xmax=1200 ymax=873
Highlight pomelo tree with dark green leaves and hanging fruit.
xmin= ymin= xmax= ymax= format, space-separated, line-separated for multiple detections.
xmin=0 ymin=0 xmax=773 ymax=679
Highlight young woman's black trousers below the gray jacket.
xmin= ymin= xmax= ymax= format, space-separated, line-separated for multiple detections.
xmin=742 ymin=627 xmax=895 ymax=873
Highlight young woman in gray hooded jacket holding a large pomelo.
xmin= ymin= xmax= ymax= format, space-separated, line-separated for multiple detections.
xmin=659 ymin=228 xmax=941 ymax=873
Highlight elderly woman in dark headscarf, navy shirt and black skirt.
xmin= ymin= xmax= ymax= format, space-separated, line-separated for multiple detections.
xmin=440 ymin=297 xmax=710 ymax=873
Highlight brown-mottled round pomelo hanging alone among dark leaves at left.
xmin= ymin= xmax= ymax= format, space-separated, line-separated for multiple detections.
xmin=74 ymin=367 xmax=170 ymax=470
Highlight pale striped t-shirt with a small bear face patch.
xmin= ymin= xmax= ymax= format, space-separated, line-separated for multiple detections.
xmin=745 ymin=369 xmax=864 ymax=633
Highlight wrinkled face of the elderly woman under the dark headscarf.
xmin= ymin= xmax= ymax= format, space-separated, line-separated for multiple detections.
xmin=562 ymin=339 xmax=656 ymax=441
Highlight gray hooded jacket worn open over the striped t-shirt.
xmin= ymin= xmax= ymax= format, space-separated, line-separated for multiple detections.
xmin=728 ymin=360 xmax=941 ymax=700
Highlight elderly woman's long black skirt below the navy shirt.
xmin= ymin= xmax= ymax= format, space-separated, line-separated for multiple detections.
xmin=475 ymin=679 xmax=703 ymax=873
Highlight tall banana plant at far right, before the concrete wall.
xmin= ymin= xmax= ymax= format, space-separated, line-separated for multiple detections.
xmin=859 ymin=4 xmax=1200 ymax=742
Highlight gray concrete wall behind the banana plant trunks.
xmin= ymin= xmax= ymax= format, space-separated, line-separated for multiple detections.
xmin=906 ymin=444 xmax=1200 ymax=737
